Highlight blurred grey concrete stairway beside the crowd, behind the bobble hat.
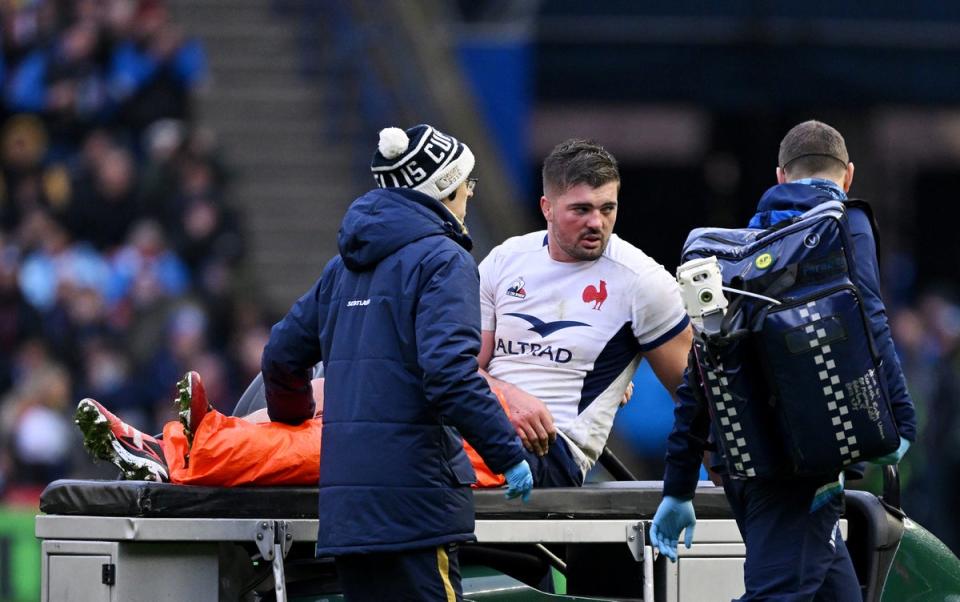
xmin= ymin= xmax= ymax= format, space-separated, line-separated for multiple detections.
xmin=171 ymin=0 xmax=360 ymax=311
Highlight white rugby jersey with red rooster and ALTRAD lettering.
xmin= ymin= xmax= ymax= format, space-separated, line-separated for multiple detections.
xmin=480 ymin=230 xmax=688 ymax=474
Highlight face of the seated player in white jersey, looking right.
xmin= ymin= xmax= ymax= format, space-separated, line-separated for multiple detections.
xmin=540 ymin=181 xmax=620 ymax=261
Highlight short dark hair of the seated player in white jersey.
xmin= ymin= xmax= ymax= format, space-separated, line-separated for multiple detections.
xmin=543 ymin=138 xmax=620 ymax=194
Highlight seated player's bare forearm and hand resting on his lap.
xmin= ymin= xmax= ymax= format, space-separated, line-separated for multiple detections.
xmin=477 ymin=330 xmax=557 ymax=456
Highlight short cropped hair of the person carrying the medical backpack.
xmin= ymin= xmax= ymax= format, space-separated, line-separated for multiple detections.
xmin=778 ymin=119 xmax=850 ymax=179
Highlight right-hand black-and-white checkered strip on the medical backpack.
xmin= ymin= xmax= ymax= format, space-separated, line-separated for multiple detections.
xmin=800 ymin=301 xmax=860 ymax=464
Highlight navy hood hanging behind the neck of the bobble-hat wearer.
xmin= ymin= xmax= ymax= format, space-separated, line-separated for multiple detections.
xmin=337 ymin=188 xmax=473 ymax=271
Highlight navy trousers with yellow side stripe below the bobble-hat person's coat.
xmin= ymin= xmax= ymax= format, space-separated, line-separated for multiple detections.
xmin=336 ymin=543 xmax=463 ymax=602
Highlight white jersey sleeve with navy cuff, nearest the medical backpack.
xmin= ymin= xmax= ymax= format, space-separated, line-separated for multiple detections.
xmin=632 ymin=264 xmax=690 ymax=351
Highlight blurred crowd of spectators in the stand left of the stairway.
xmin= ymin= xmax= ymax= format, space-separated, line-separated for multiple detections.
xmin=0 ymin=0 xmax=269 ymax=501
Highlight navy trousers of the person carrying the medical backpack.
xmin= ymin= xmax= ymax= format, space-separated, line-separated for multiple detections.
xmin=724 ymin=476 xmax=863 ymax=602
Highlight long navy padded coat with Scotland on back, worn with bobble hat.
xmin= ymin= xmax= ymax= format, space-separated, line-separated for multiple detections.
xmin=262 ymin=188 xmax=523 ymax=555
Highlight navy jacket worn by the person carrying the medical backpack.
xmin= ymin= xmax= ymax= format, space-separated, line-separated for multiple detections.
xmin=663 ymin=183 xmax=917 ymax=499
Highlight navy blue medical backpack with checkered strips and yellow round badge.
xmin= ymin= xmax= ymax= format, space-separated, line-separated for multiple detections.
xmin=682 ymin=201 xmax=899 ymax=477
